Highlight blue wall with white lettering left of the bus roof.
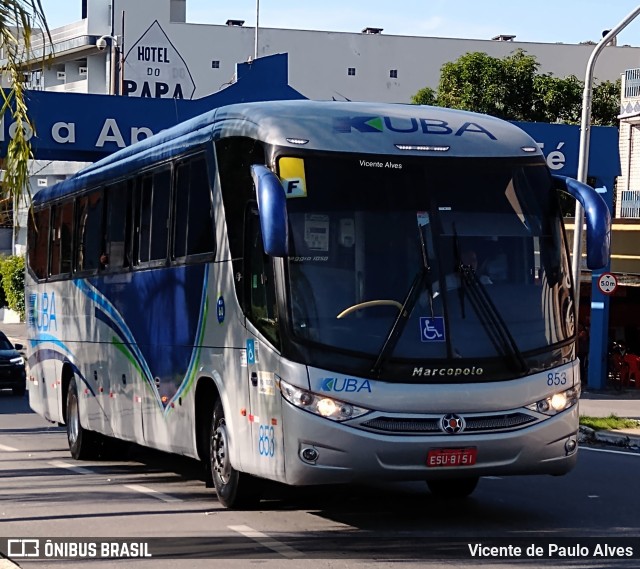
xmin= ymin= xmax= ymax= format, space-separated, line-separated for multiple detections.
xmin=0 ymin=54 xmax=306 ymax=162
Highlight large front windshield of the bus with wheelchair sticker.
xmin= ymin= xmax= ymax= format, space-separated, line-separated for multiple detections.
xmin=279 ymin=155 xmax=574 ymax=371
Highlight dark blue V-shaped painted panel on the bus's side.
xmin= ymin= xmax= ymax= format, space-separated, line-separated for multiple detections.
xmin=74 ymin=264 xmax=209 ymax=412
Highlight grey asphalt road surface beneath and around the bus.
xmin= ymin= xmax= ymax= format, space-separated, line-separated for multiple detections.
xmin=0 ymin=391 xmax=640 ymax=569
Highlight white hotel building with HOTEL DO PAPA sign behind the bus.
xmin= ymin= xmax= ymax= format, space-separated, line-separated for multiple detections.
xmin=31 ymin=0 xmax=640 ymax=103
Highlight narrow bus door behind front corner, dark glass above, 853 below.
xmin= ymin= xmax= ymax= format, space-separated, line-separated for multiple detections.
xmin=245 ymin=209 xmax=284 ymax=477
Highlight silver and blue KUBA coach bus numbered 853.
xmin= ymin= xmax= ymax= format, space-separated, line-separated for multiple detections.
xmin=26 ymin=100 xmax=610 ymax=508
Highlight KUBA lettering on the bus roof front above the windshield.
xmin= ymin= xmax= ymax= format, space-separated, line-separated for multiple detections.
xmin=333 ymin=116 xmax=497 ymax=140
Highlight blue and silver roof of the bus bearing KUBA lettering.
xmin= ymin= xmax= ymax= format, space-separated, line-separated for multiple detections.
xmin=33 ymin=100 xmax=542 ymax=204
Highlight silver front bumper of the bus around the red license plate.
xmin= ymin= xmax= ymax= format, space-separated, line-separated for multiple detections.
xmin=283 ymin=402 xmax=578 ymax=485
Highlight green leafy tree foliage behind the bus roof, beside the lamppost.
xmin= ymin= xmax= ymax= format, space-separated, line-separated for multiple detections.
xmin=412 ymin=49 xmax=620 ymax=125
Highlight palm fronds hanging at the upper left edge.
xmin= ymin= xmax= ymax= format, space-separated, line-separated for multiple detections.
xmin=0 ymin=0 xmax=51 ymax=206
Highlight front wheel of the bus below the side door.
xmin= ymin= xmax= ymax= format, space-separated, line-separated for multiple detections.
xmin=208 ymin=399 xmax=261 ymax=509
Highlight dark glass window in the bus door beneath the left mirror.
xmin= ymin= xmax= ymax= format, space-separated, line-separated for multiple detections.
xmin=245 ymin=210 xmax=280 ymax=347
